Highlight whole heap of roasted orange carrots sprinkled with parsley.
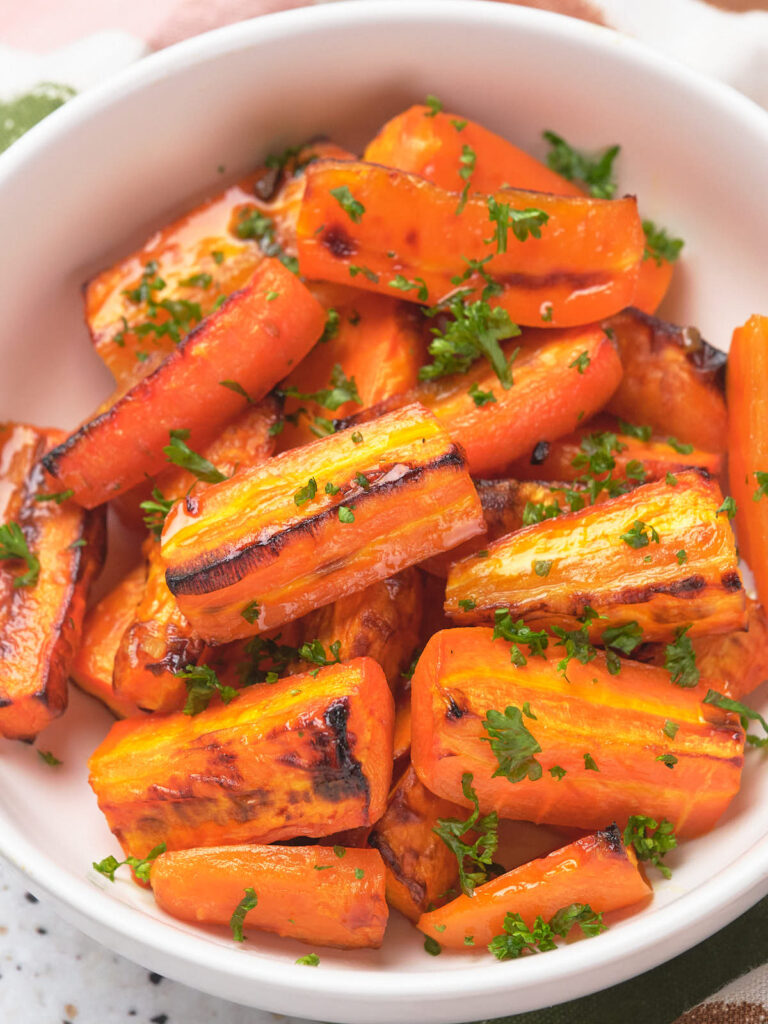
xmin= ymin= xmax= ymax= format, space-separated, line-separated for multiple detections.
xmin=0 ymin=97 xmax=768 ymax=966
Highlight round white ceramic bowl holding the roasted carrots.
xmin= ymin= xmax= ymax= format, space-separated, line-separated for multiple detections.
xmin=0 ymin=0 xmax=768 ymax=1024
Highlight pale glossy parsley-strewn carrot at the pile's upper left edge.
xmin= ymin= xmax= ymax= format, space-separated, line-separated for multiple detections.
xmin=85 ymin=141 xmax=349 ymax=385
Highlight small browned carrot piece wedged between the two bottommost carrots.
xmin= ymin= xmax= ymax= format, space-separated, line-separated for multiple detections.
xmin=369 ymin=766 xmax=464 ymax=921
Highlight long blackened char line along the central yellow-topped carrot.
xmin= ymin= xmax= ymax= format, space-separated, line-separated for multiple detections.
xmin=166 ymin=443 xmax=466 ymax=595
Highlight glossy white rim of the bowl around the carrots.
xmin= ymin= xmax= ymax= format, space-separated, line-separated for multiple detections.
xmin=0 ymin=0 xmax=768 ymax=1020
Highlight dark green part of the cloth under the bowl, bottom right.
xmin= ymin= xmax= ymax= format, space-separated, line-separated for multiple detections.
xmin=477 ymin=899 xmax=768 ymax=1024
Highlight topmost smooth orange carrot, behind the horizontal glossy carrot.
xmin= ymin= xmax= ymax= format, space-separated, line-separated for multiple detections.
xmin=364 ymin=104 xmax=584 ymax=196
